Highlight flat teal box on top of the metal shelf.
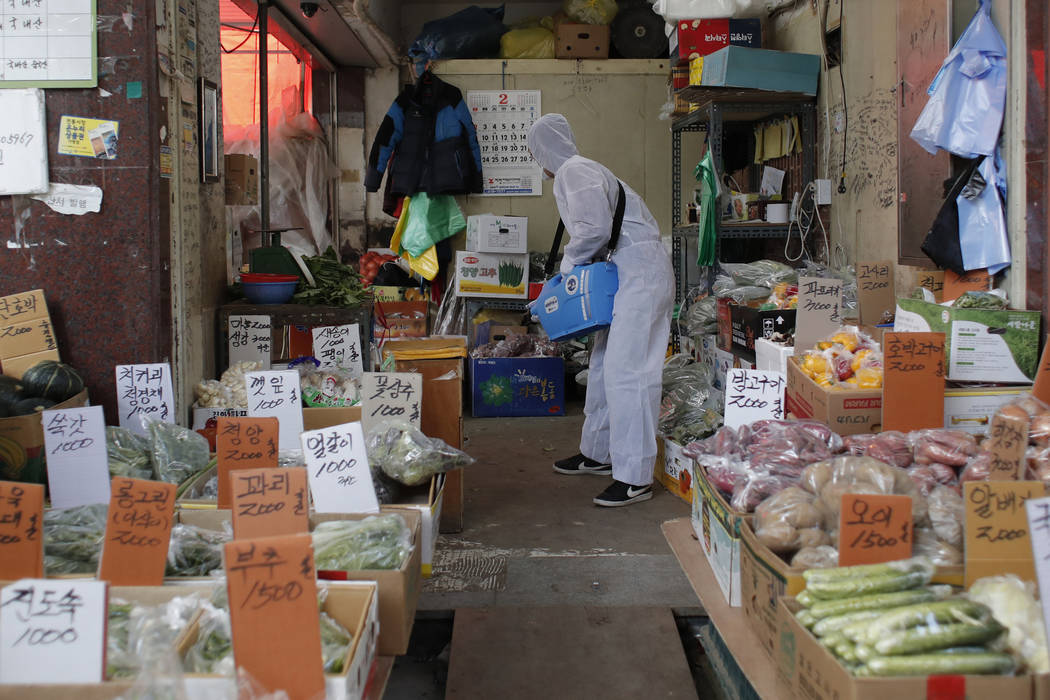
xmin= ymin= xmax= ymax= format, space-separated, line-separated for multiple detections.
xmin=701 ymin=46 xmax=820 ymax=94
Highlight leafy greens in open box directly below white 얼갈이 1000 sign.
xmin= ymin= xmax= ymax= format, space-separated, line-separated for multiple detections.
xmin=313 ymin=513 xmax=412 ymax=571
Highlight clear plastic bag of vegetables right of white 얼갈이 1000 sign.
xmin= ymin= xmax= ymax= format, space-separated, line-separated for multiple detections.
xmin=365 ymin=423 xmax=475 ymax=486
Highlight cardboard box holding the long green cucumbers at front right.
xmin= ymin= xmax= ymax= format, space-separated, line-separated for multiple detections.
xmin=776 ymin=598 xmax=1032 ymax=700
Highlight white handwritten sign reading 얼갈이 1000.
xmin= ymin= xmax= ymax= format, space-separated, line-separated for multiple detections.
xmin=302 ymin=423 xmax=379 ymax=513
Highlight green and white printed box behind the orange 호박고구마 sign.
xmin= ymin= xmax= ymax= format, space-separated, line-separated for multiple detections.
xmin=894 ymin=299 xmax=1043 ymax=384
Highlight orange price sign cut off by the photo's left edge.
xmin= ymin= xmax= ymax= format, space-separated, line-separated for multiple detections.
xmin=0 ymin=482 xmax=44 ymax=580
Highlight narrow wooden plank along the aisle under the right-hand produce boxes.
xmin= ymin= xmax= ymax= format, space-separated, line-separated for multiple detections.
xmin=660 ymin=517 xmax=791 ymax=700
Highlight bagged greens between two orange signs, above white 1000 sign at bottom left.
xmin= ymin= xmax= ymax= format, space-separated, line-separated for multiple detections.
xmin=44 ymin=504 xmax=109 ymax=576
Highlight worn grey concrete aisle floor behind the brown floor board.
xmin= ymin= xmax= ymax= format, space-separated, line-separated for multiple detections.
xmin=384 ymin=403 xmax=702 ymax=700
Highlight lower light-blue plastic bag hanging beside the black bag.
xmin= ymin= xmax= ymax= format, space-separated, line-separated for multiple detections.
xmin=956 ymin=152 xmax=1010 ymax=275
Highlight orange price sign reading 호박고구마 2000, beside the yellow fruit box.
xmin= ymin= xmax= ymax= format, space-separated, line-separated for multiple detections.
xmin=882 ymin=333 xmax=944 ymax=432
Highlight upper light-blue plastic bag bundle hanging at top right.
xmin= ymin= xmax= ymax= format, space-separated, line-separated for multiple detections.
xmin=911 ymin=0 xmax=1006 ymax=158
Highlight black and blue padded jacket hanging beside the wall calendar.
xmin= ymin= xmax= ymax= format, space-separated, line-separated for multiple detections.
xmin=364 ymin=70 xmax=482 ymax=195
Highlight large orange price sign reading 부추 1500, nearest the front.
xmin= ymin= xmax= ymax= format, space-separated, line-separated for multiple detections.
xmin=226 ymin=534 xmax=324 ymax=700
